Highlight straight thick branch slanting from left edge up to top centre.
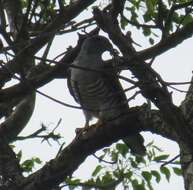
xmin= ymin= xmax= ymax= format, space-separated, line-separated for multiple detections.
xmin=0 ymin=0 xmax=95 ymax=86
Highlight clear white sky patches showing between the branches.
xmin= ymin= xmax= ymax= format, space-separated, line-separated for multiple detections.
xmin=3 ymin=1 xmax=193 ymax=190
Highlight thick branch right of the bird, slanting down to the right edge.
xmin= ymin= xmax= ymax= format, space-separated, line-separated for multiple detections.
xmin=94 ymin=9 xmax=193 ymax=146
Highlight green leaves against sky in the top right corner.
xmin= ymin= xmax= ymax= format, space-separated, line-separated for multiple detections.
xmin=120 ymin=0 xmax=193 ymax=44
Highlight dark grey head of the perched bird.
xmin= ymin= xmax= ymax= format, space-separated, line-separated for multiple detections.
xmin=82 ymin=35 xmax=113 ymax=54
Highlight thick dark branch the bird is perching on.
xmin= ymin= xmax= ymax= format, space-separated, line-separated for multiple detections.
xmin=8 ymin=106 xmax=175 ymax=190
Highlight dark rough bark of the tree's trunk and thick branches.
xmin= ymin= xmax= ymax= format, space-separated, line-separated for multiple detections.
xmin=0 ymin=0 xmax=193 ymax=190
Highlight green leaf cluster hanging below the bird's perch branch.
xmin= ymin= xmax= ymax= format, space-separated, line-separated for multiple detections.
xmin=62 ymin=142 xmax=181 ymax=190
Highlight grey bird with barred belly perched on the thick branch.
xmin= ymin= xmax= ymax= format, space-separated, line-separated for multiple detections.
xmin=67 ymin=35 xmax=146 ymax=156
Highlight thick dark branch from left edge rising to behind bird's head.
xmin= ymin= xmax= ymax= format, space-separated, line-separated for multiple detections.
xmin=0 ymin=28 xmax=99 ymax=103
